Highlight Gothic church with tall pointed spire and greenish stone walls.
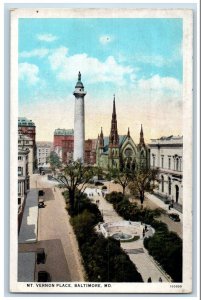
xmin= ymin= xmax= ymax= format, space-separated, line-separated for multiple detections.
xmin=96 ymin=96 xmax=150 ymax=170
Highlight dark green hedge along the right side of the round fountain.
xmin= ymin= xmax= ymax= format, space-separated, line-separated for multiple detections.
xmin=106 ymin=192 xmax=182 ymax=282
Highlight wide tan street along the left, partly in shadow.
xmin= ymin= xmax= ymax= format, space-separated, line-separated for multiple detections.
xmin=28 ymin=174 xmax=84 ymax=282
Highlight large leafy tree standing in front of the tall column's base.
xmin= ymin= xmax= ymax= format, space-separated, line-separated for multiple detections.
xmin=57 ymin=160 xmax=97 ymax=212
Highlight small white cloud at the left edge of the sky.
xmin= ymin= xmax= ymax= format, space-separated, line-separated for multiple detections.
xmin=18 ymin=63 xmax=39 ymax=85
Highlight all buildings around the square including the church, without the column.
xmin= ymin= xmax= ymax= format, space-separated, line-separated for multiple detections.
xmin=18 ymin=112 xmax=183 ymax=216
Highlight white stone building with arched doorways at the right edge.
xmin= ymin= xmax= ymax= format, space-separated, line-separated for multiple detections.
xmin=149 ymin=136 xmax=183 ymax=205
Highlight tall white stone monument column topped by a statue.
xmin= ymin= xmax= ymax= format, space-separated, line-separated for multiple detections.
xmin=73 ymin=72 xmax=86 ymax=162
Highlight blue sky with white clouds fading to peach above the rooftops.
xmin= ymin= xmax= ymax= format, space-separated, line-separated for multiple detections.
xmin=19 ymin=18 xmax=183 ymax=143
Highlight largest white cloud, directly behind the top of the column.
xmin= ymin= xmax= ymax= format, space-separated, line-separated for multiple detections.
xmin=49 ymin=47 xmax=134 ymax=86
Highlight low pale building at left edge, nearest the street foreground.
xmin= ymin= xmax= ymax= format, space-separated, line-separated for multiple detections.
xmin=18 ymin=147 xmax=29 ymax=229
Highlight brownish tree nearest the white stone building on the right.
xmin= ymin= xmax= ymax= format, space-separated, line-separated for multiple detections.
xmin=129 ymin=168 xmax=158 ymax=204
